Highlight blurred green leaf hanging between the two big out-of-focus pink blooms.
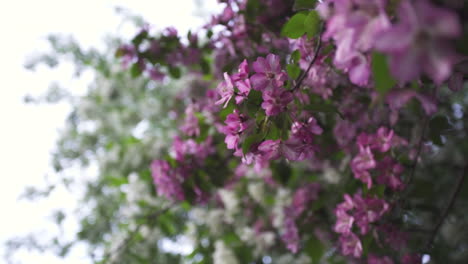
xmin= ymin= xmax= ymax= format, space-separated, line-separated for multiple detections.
xmin=372 ymin=52 xmax=396 ymax=96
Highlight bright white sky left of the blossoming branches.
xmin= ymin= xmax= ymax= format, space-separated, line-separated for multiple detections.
xmin=0 ymin=0 xmax=216 ymax=264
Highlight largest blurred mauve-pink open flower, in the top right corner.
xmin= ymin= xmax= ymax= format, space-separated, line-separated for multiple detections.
xmin=376 ymin=0 xmax=461 ymax=83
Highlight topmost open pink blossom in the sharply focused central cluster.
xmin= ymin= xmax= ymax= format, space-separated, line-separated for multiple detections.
xmin=250 ymin=54 xmax=287 ymax=91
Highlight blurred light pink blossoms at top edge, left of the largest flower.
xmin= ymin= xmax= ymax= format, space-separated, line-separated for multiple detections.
xmin=319 ymin=0 xmax=390 ymax=86
